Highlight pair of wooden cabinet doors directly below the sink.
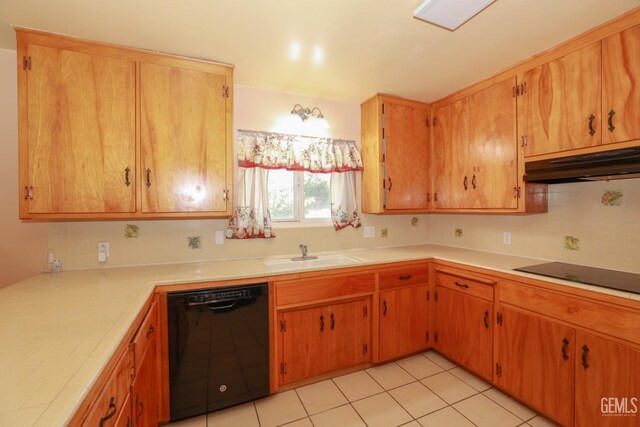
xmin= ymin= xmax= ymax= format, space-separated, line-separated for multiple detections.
xmin=278 ymin=297 xmax=371 ymax=384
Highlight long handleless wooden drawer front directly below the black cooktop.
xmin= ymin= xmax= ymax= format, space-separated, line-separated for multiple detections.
xmin=500 ymin=282 xmax=640 ymax=344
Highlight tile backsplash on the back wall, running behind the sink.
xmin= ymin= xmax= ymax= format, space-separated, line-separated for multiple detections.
xmin=48 ymin=215 xmax=431 ymax=270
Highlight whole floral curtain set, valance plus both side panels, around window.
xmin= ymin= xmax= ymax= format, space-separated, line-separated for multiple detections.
xmin=226 ymin=130 xmax=363 ymax=239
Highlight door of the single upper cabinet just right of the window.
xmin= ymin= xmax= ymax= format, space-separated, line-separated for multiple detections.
xmin=384 ymin=102 xmax=430 ymax=209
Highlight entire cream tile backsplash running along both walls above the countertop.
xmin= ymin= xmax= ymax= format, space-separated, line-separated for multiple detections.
xmin=48 ymin=179 xmax=640 ymax=272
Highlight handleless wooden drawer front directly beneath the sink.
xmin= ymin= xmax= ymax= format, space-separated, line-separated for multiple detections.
xmin=275 ymin=273 xmax=376 ymax=306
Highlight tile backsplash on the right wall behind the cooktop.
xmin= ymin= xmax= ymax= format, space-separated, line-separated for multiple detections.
xmin=429 ymin=179 xmax=640 ymax=272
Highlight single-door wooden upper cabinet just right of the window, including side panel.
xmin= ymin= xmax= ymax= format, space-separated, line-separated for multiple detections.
xmin=361 ymin=95 xmax=431 ymax=213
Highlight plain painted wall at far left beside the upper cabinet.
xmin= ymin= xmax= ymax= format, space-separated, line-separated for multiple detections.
xmin=0 ymin=49 xmax=47 ymax=288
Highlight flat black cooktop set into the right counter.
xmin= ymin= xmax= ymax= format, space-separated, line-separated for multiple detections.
xmin=514 ymin=262 xmax=640 ymax=294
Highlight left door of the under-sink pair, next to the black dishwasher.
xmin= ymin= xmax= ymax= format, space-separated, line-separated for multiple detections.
xmin=280 ymin=307 xmax=329 ymax=384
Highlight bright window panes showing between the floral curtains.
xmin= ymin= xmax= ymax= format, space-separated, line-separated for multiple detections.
xmin=267 ymin=169 xmax=331 ymax=222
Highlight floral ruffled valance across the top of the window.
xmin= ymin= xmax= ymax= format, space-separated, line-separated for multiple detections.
xmin=238 ymin=130 xmax=362 ymax=173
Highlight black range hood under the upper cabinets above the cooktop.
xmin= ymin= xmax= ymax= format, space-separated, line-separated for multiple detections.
xmin=524 ymin=147 xmax=640 ymax=184
